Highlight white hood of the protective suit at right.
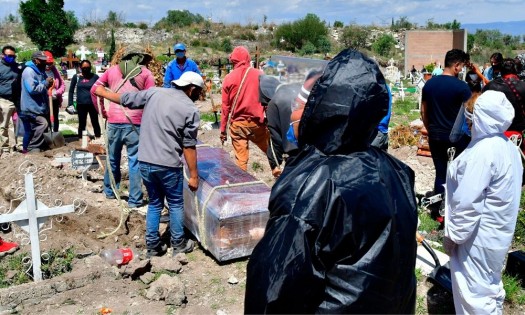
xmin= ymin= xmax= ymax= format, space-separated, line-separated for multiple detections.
xmin=472 ymin=91 xmax=514 ymax=140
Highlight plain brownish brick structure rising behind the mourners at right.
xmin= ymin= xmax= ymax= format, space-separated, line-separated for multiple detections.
xmin=405 ymin=30 xmax=467 ymax=74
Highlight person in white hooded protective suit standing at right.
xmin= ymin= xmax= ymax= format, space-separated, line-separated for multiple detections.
xmin=445 ymin=91 xmax=523 ymax=314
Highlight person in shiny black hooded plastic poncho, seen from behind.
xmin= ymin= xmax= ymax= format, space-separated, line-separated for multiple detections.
xmin=245 ymin=50 xmax=417 ymax=314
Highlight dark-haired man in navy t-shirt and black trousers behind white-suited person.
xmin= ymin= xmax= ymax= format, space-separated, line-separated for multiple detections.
xmin=421 ymin=49 xmax=471 ymax=217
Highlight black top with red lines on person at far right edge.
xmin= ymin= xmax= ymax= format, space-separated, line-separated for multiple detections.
xmin=483 ymin=77 xmax=525 ymax=132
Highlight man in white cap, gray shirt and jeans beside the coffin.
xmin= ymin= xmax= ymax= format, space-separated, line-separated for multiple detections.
xmin=95 ymin=72 xmax=204 ymax=257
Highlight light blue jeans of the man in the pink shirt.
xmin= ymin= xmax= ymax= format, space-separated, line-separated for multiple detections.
xmin=104 ymin=124 xmax=143 ymax=208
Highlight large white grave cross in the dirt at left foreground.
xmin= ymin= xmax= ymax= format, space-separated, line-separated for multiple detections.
xmin=0 ymin=173 xmax=75 ymax=281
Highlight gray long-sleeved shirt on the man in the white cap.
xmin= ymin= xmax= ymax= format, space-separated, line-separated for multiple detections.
xmin=120 ymin=88 xmax=200 ymax=167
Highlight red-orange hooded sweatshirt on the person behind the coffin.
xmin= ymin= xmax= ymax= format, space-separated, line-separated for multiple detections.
xmin=221 ymin=46 xmax=264 ymax=132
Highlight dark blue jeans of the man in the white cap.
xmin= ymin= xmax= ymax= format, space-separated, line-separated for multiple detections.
xmin=140 ymin=162 xmax=185 ymax=249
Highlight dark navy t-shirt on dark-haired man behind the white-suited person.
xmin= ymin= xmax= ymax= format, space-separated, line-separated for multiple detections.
xmin=423 ymin=75 xmax=472 ymax=141
